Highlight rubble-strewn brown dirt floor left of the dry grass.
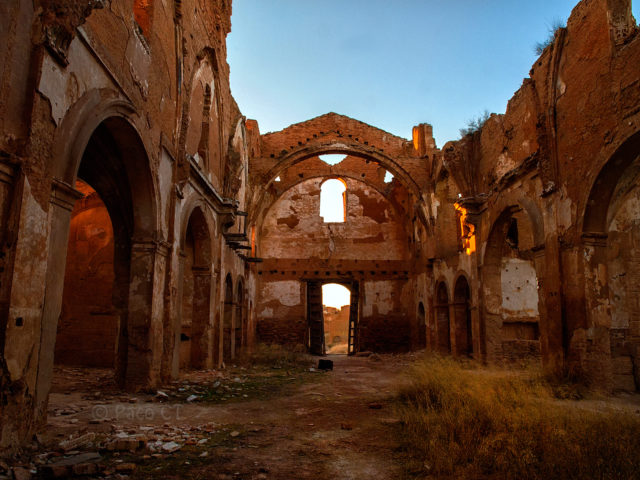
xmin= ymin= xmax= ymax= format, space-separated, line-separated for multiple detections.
xmin=17 ymin=355 xmax=415 ymax=480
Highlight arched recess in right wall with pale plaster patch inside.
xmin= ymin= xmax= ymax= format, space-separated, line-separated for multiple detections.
xmin=481 ymin=204 xmax=544 ymax=361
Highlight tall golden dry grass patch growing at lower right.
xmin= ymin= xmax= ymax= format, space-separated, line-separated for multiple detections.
xmin=398 ymin=357 xmax=640 ymax=480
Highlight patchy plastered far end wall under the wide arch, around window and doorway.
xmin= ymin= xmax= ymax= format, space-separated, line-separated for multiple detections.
xmin=256 ymin=173 xmax=415 ymax=352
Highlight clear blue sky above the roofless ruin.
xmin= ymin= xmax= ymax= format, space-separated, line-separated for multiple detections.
xmin=228 ymin=0 xmax=640 ymax=147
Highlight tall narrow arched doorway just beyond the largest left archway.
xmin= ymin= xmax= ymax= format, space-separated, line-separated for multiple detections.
xmin=180 ymin=207 xmax=214 ymax=369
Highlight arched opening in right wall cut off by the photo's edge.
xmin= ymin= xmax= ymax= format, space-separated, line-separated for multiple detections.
xmin=581 ymin=132 xmax=640 ymax=391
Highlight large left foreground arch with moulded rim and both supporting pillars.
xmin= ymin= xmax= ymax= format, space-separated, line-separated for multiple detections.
xmin=37 ymin=89 xmax=161 ymax=405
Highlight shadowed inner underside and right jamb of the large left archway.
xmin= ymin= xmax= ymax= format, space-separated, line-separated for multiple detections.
xmin=51 ymin=116 xmax=161 ymax=386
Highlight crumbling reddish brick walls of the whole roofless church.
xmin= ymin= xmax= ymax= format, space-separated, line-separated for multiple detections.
xmin=0 ymin=0 xmax=640 ymax=478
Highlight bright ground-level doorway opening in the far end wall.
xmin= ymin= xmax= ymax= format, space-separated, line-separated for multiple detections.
xmin=322 ymin=283 xmax=351 ymax=355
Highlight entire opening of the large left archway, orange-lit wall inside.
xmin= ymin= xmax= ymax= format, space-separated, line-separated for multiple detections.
xmin=52 ymin=117 xmax=162 ymax=387
